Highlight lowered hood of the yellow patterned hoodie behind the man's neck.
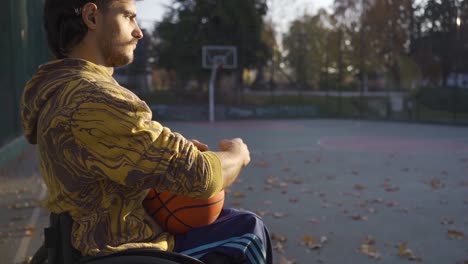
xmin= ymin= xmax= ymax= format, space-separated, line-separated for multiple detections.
xmin=21 ymin=59 xmax=115 ymax=144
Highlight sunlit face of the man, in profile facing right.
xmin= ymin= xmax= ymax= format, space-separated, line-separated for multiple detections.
xmin=98 ymin=0 xmax=143 ymax=67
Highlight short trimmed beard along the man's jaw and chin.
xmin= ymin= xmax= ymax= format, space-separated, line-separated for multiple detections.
xmin=101 ymin=34 xmax=134 ymax=67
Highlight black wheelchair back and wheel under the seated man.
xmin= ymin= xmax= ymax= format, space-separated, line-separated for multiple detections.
xmin=29 ymin=213 xmax=203 ymax=264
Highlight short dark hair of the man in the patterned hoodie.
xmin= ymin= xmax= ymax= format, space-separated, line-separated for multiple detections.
xmin=44 ymin=0 xmax=115 ymax=59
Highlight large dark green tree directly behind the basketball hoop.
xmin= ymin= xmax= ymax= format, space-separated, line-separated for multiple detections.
xmin=153 ymin=0 xmax=271 ymax=93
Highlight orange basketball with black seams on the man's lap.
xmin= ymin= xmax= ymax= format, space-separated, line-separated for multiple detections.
xmin=143 ymin=188 xmax=224 ymax=234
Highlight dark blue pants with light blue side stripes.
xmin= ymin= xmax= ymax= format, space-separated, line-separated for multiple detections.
xmin=174 ymin=208 xmax=273 ymax=264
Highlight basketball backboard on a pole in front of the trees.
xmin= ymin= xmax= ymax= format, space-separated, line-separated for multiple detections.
xmin=202 ymin=45 xmax=237 ymax=69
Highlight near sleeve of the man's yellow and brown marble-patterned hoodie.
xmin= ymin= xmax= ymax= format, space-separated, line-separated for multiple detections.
xmin=71 ymin=82 xmax=222 ymax=198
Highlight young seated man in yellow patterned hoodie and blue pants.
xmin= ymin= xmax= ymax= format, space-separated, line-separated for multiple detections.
xmin=21 ymin=0 xmax=271 ymax=263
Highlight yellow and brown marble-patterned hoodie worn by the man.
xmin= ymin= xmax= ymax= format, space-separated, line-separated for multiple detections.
xmin=21 ymin=59 xmax=222 ymax=255
